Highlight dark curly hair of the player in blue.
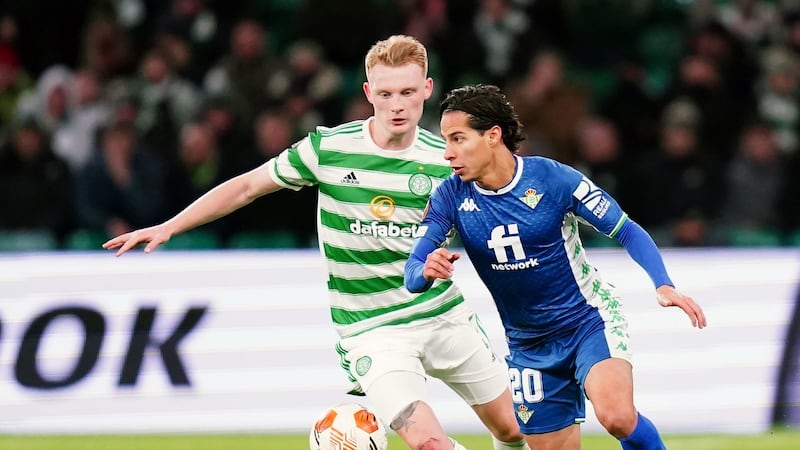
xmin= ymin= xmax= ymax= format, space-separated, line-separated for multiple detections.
xmin=439 ymin=84 xmax=525 ymax=153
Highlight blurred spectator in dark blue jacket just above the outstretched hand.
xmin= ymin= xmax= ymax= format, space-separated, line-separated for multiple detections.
xmin=75 ymin=124 xmax=170 ymax=236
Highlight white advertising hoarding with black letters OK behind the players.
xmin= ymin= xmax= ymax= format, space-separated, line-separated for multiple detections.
xmin=0 ymin=249 xmax=800 ymax=433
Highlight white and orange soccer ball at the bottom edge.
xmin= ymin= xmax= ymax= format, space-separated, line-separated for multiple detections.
xmin=308 ymin=403 xmax=389 ymax=450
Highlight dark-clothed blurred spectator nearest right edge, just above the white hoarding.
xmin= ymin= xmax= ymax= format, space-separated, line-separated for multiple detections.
xmin=720 ymin=123 xmax=783 ymax=234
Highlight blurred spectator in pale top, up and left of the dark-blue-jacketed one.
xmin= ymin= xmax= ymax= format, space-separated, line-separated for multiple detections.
xmin=53 ymin=69 xmax=111 ymax=174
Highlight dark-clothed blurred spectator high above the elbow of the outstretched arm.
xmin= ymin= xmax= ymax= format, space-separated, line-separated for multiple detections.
xmin=203 ymin=19 xmax=282 ymax=123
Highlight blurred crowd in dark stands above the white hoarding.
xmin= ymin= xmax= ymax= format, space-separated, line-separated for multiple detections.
xmin=0 ymin=0 xmax=800 ymax=249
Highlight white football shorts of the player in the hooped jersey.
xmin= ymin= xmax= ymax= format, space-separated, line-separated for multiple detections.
xmin=338 ymin=305 xmax=508 ymax=423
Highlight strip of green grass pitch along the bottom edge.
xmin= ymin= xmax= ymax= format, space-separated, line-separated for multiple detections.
xmin=0 ymin=430 xmax=800 ymax=450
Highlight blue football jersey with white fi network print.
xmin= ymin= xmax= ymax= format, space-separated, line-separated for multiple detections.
xmin=419 ymin=156 xmax=627 ymax=341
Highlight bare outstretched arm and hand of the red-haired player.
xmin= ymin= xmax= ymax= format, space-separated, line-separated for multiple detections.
xmin=103 ymin=164 xmax=282 ymax=256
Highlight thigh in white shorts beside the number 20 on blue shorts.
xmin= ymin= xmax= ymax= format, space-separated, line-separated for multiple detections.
xmin=422 ymin=314 xmax=508 ymax=406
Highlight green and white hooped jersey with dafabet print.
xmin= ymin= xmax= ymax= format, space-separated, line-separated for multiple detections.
xmin=267 ymin=119 xmax=464 ymax=337
